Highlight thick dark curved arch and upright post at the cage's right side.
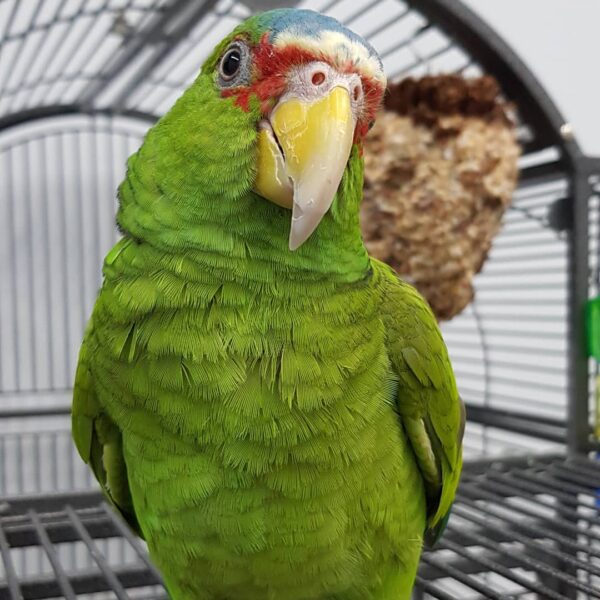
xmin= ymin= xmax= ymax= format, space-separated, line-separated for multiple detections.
xmin=409 ymin=0 xmax=600 ymax=453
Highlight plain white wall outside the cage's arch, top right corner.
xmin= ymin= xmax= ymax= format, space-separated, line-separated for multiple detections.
xmin=463 ymin=0 xmax=600 ymax=156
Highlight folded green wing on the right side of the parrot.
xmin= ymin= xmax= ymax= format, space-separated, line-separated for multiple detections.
xmin=384 ymin=274 xmax=465 ymax=545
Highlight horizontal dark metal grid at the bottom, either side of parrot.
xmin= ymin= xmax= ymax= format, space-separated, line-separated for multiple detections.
xmin=0 ymin=457 xmax=600 ymax=600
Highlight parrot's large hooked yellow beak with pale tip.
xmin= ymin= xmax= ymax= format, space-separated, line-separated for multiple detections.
xmin=254 ymin=86 xmax=356 ymax=250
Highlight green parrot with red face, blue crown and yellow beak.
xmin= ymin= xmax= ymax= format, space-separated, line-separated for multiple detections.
xmin=72 ymin=9 xmax=464 ymax=600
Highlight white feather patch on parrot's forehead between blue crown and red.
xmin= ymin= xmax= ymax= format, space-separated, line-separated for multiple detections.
xmin=274 ymin=30 xmax=386 ymax=87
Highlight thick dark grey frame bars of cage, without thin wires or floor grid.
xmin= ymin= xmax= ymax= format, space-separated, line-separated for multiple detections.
xmin=0 ymin=0 xmax=600 ymax=453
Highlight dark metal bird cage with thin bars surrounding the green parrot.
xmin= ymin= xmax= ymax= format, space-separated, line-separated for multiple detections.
xmin=0 ymin=0 xmax=600 ymax=600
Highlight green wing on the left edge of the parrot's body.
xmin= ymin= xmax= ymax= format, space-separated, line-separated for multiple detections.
xmin=71 ymin=323 xmax=143 ymax=537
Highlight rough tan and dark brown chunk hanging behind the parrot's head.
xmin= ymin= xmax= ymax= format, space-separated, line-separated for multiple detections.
xmin=361 ymin=75 xmax=520 ymax=320
